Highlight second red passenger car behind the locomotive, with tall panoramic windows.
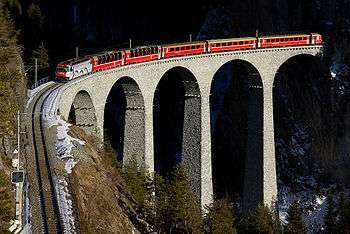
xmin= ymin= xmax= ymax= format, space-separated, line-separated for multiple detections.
xmin=125 ymin=46 xmax=161 ymax=64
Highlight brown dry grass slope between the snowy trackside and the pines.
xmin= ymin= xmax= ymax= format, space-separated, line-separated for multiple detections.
xmin=70 ymin=127 xmax=140 ymax=233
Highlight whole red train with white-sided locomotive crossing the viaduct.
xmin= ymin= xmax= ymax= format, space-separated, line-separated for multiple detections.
xmin=55 ymin=33 xmax=322 ymax=81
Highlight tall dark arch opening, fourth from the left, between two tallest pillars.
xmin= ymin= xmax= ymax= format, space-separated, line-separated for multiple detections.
xmin=210 ymin=59 xmax=263 ymax=212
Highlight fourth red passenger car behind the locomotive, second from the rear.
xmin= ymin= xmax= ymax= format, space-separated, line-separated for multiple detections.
xmin=208 ymin=37 xmax=256 ymax=52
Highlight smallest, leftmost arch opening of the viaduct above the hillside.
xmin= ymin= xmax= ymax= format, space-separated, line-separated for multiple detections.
xmin=68 ymin=90 xmax=98 ymax=136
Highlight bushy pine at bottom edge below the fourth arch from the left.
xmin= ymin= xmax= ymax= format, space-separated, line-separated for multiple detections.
xmin=203 ymin=198 xmax=237 ymax=234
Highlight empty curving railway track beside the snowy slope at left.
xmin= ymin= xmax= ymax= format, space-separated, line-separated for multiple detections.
xmin=27 ymin=84 xmax=63 ymax=233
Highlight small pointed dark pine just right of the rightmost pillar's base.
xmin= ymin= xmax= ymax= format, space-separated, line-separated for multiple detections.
xmin=285 ymin=202 xmax=306 ymax=234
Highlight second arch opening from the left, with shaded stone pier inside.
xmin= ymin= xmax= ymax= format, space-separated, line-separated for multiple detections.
xmin=104 ymin=77 xmax=145 ymax=165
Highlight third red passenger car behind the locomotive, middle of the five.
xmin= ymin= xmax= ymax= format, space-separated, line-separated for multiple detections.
xmin=162 ymin=41 xmax=206 ymax=58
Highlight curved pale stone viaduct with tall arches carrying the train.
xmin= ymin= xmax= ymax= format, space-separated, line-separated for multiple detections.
xmin=54 ymin=46 xmax=323 ymax=211
